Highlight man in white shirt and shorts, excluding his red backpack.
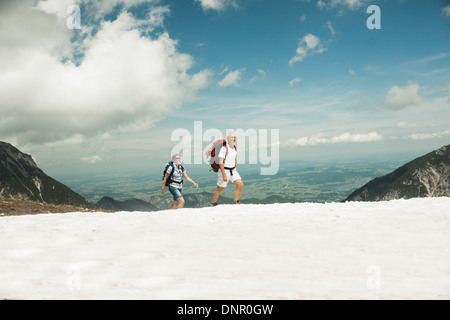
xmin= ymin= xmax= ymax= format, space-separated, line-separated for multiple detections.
xmin=211 ymin=132 xmax=244 ymax=207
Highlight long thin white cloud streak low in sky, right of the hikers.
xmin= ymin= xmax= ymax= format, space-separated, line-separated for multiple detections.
xmin=287 ymin=132 xmax=383 ymax=147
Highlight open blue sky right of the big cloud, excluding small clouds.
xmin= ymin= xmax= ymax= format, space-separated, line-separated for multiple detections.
xmin=156 ymin=1 xmax=450 ymax=165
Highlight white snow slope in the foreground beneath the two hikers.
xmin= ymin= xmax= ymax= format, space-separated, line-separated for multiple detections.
xmin=0 ymin=198 xmax=450 ymax=299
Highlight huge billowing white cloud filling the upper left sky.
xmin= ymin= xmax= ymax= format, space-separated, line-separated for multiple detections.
xmin=0 ymin=0 xmax=211 ymax=144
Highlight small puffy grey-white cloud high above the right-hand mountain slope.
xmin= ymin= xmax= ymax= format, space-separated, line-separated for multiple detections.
xmin=384 ymin=81 xmax=424 ymax=109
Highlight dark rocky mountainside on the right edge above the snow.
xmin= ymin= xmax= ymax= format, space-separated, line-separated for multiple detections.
xmin=345 ymin=145 xmax=450 ymax=201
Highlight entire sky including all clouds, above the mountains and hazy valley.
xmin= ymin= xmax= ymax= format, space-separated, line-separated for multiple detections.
xmin=0 ymin=0 xmax=450 ymax=173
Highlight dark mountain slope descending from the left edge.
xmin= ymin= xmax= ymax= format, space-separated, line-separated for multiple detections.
xmin=0 ymin=141 xmax=93 ymax=208
